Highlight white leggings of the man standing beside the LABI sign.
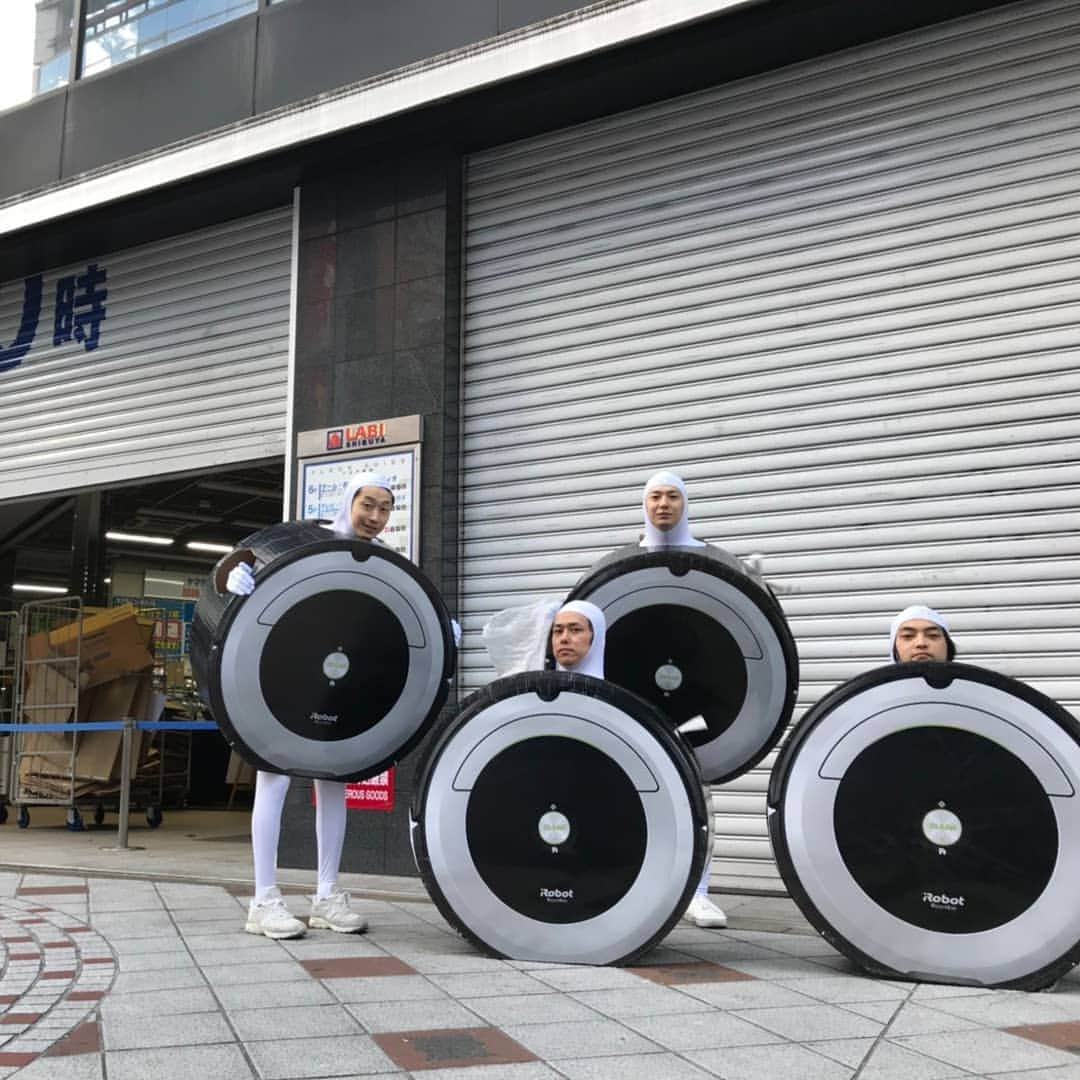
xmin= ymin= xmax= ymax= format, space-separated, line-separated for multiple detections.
xmin=252 ymin=771 xmax=346 ymax=897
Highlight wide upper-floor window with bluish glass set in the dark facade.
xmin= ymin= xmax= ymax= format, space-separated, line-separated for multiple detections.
xmin=82 ymin=0 xmax=258 ymax=76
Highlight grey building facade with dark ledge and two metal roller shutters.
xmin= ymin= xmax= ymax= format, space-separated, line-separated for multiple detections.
xmin=0 ymin=0 xmax=1080 ymax=891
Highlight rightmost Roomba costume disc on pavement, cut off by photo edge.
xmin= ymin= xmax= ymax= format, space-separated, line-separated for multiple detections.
xmin=768 ymin=662 xmax=1080 ymax=990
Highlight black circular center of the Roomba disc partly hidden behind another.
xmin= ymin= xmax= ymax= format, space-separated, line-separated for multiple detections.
xmin=604 ymin=604 xmax=746 ymax=746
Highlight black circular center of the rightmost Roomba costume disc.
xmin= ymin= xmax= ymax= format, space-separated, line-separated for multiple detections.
xmin=833 ymin=727 xmax=1057 ymax=933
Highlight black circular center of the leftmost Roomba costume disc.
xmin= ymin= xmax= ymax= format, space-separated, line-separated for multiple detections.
xmin=259 ymin=589 xmax=409 ymax=742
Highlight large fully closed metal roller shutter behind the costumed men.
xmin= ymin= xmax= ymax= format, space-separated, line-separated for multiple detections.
xmin=463 ymin=3 xmax=1080 ymax=891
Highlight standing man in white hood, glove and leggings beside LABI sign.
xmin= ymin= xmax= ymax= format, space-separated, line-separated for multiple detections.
xmin=226 ymin=473 xmax=394 ymax=939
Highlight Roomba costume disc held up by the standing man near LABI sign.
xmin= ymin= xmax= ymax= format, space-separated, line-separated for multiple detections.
xmin=191 ymin=522 xmax=456 ymax=780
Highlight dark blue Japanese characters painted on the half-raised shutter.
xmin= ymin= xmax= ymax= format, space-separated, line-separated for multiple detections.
xmin=0 ymin=262 xmax=109 ymax=373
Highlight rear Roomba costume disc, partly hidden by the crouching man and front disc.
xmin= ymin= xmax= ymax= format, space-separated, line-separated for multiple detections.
xmin=568 ymin=544 xmax=799 ymax=783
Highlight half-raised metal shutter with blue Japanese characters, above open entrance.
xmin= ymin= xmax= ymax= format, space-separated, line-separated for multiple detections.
xmin=0 ymin=207 xmax=293 ymax=499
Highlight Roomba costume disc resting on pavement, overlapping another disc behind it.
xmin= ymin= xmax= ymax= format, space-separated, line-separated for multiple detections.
xmin=411 ymin=672 xmax=708 ymax=964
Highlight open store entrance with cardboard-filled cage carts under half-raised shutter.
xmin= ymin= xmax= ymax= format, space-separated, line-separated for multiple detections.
xmin=0 ymin=459 xmax=284 ymax=829
